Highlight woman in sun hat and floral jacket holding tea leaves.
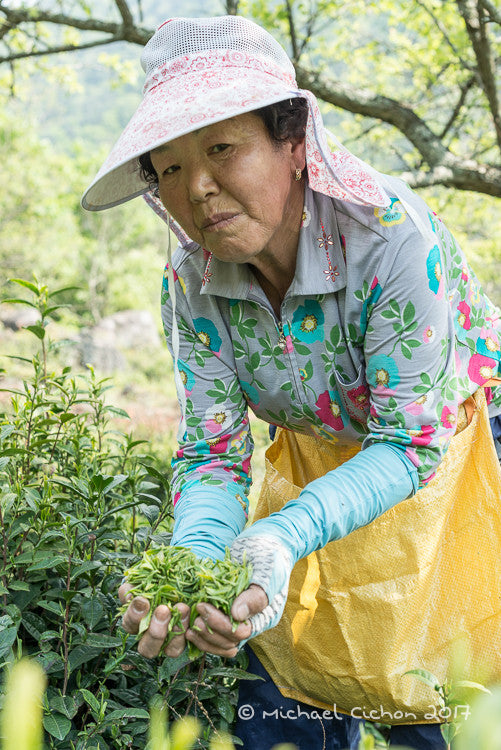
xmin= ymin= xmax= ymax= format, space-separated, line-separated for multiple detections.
xmin=83 ymin=16 xmax=501 ymax=749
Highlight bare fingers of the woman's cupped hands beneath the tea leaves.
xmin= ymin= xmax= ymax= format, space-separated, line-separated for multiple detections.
xmin=118 ymin=583 xmax=268 ymax=659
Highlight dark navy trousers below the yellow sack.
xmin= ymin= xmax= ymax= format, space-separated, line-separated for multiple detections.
xmin=234 ymin=648 xmax=446 ymax=750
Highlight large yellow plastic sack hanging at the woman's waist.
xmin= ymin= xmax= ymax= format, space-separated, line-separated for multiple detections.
xmin=250 ymin=389 xmax=501 ymax=724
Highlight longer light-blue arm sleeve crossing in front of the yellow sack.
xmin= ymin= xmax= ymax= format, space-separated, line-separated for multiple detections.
xmin=239 ymin=443 xmax=418 ymax=563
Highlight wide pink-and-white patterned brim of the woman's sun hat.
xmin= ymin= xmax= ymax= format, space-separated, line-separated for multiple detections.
xmin=82 ymin=67 xmax=302 ymax=211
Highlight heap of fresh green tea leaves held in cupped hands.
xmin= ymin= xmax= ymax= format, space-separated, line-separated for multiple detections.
xmin=121 ymin=547 xmax=252 ymax=659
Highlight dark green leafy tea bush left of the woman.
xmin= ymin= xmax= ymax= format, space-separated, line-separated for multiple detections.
xmin=0 ymin=280 xmax=250 ymax=750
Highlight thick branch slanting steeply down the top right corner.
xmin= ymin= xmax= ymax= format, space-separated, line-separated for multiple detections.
xmin=456 ymin=0 xmax=501 ymax=151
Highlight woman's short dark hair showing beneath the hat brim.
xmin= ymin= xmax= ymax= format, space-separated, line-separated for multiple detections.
xmin=139 ymin=97 xmax=308 ymax=189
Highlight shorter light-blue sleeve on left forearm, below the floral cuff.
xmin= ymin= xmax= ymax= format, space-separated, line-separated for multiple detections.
xmin=171 ymin=485 xmax=246 ymax=560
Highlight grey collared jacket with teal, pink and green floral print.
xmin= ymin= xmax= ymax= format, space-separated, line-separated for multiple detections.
xmin=162 ymin=178 xmax=501 ymax=516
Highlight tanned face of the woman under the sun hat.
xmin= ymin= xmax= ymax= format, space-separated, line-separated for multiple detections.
xmin=151 ymin=113 xmax=305 ymax=266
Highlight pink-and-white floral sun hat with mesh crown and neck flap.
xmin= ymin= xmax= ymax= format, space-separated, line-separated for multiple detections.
xmin=82 ymin=16 xmax=390 ymax=213
